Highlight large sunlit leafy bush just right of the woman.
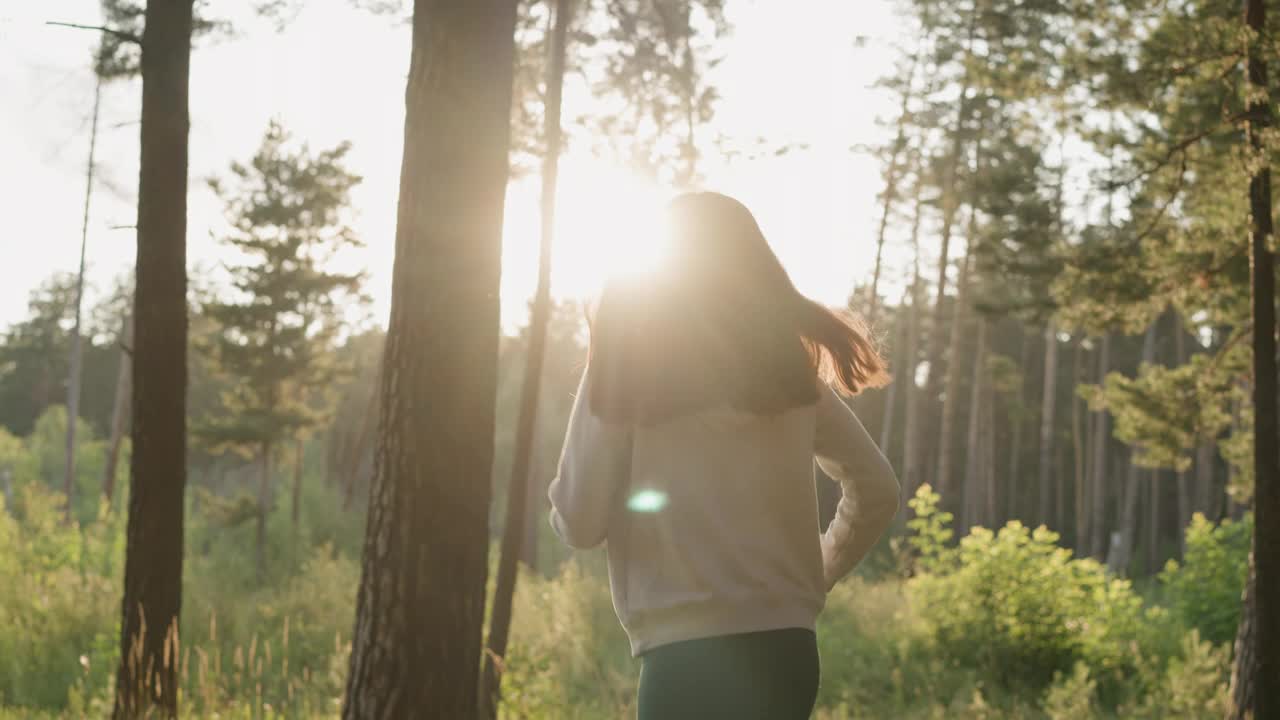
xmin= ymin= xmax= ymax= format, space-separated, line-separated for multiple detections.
xmin=910 ymin=486 xmax=1144 ymax=694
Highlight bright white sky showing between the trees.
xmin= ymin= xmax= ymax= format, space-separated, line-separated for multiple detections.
xmin=0 ymin=0 xmax=906 ymax=328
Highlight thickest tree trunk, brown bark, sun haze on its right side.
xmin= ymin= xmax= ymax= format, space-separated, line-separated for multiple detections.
xmin=343 ymin=0 xmax=516 ymax=720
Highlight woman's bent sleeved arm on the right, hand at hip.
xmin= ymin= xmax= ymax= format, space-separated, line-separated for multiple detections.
xmin=814 ymin=386 xmax=899 ymax=591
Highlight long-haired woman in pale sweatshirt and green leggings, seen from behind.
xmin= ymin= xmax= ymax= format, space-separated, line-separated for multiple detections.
xmin=550 ymin=193 xmax=899 ymax=720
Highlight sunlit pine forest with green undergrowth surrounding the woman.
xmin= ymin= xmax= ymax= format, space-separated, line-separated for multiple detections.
xmin=0 ymin=0 xmax=1280 ymax=720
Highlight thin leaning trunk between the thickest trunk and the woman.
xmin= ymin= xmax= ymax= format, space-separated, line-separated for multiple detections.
xmin=480 ymin=0 xmax=573 ymax=719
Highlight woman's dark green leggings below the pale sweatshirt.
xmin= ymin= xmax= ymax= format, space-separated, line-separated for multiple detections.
xmin=639 ymin=629 xmax=818 ymax=720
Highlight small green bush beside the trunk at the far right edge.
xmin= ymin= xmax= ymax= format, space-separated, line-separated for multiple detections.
xmin=1160 ymin=512 xmax=1253 ymax=644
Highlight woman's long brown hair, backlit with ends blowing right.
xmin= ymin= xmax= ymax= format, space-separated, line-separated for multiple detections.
xmin=590 ymin=192 xmax=890 ymax=424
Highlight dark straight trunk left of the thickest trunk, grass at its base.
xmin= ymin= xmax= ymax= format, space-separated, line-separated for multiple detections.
xmin=113 ymin=0 xmax=193 ymax=720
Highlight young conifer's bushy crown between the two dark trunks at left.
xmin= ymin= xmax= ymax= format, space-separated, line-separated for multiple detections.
xmin=200 ymin=122 xmax=364 ymax=448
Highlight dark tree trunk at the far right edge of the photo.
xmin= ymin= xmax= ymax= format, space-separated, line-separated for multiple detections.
xmin=1236 ymin=0 xmax=1280 ymax=707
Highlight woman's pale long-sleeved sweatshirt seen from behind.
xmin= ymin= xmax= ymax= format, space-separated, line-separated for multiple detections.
xmin=549 ymin=368 xmax=899 ymax=655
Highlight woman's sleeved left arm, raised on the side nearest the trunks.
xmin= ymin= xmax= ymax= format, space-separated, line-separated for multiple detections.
xmin=548 ymin=365 xmax=631 ymax=550
